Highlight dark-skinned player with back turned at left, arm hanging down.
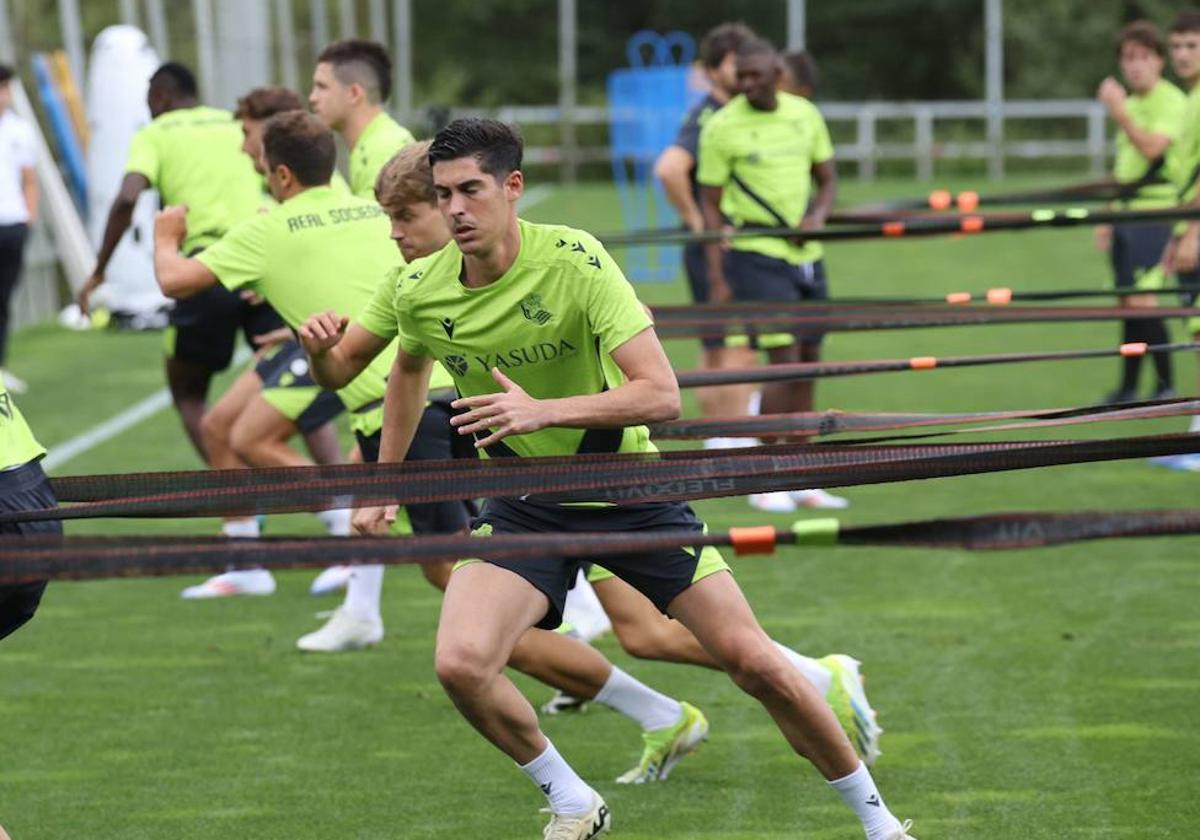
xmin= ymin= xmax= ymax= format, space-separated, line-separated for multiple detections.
xmin=79 ymin=62 xmax=283 ymax=462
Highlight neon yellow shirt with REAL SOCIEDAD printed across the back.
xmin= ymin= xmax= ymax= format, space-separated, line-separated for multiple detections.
xmin=197 ymin=186 xmax=396 ymax=420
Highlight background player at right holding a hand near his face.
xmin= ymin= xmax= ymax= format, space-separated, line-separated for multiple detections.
xmin=1096 ymin=20 xmax=1187 ymax=403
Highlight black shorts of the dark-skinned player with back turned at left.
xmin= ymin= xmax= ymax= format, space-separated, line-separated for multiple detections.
xmin=167 ymin=286 xmax=283 ymax=373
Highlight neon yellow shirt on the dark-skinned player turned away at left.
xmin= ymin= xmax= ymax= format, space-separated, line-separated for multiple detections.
xmin=125 ymin=106 xmax=263 ymax=253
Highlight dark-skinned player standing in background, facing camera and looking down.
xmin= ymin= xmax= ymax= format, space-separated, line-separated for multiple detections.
xmin=696 ymin=37 xmax=847 ymax=511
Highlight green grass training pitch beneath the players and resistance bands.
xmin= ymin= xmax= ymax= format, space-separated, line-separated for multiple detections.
xmin=0 ymin=179 xmax=1200 ymax=840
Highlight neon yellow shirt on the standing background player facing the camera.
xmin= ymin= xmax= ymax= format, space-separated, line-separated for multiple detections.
xmin=696 ymin=91 xmax=833 ymax=265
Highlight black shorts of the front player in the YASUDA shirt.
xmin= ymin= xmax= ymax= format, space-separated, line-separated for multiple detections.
xmin=472 ymin=499 xmax=728 ymax=630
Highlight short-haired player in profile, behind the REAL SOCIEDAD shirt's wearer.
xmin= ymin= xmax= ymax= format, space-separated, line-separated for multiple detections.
xmin=308 ymin=40 xmax=413 ymax=198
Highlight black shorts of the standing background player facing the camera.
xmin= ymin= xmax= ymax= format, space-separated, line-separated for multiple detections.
xmin=725 ymin=250 xmax=829 ymax=349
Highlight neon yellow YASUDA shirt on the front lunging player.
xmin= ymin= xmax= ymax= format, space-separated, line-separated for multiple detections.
xmin=379 ymin=221 xmax=655 ymax=456
